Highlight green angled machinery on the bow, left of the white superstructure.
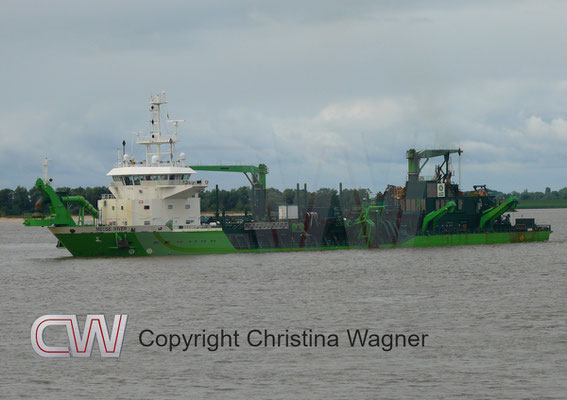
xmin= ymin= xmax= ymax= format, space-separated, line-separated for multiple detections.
xmin=24 ymin=178 xmax=98 ymax=226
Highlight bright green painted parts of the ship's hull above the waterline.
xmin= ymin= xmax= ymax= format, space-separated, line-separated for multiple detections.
xmin=51 ymin=228 xmax=551 ymax=257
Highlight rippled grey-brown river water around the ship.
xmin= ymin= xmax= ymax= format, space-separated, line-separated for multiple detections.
xmin=0 ymin=210 xmax=567 ymax=399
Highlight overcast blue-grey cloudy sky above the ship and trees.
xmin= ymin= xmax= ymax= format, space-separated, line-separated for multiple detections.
xmin=0 ymin=0 xmax=567 ymax=192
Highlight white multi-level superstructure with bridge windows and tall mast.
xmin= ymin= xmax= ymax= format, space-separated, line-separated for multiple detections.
xmin=98 ymin=93 xmax=207 ymax=230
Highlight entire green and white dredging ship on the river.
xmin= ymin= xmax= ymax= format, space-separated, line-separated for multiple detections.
xmin=24 ymin=93 xmax=551 ymax=257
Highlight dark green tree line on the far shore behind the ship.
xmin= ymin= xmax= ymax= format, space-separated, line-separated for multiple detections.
xmin=0 ymin=186 xmax=567 ymax=216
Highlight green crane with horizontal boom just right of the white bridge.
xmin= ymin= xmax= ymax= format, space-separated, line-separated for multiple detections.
xmin=191 ymin=164 xmax=268 ymax=220
